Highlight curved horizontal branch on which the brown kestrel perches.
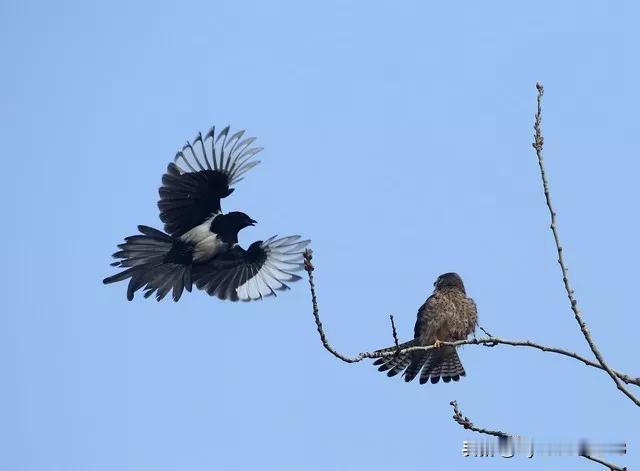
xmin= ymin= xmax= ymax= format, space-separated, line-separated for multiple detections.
xmin=304 ymin=250 xmax=640 ymax=386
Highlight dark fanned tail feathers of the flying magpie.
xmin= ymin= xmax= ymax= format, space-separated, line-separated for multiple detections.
xmin=103 ymin=226 xmax=192 ymax=301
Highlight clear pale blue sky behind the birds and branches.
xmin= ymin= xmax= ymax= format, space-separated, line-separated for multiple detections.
xmin=0 ymin=0 xmax=640 ymax=471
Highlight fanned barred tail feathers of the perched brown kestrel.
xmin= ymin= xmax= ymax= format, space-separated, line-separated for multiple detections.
xmin=373 ymin=340 xmax=466 ymax=384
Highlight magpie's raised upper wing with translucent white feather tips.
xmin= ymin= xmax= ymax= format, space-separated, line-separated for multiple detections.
xmin=158 ymin=126 xmax=262 ymax=237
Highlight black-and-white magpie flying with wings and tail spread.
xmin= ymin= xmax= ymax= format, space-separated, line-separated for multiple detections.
xmin=103 ymin=126 xmax=309 ymax=301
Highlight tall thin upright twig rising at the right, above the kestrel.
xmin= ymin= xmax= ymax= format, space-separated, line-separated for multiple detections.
xmin=532 ymin=83 xmax=640 ymax=406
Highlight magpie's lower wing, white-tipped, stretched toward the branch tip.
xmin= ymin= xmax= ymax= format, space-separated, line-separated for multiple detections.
xmin=192 ymin=236 xmax=309 ymax=301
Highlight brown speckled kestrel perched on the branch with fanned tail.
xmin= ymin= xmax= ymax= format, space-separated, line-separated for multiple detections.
xmin=374 ymin=273 xmax=478 ymax=384
